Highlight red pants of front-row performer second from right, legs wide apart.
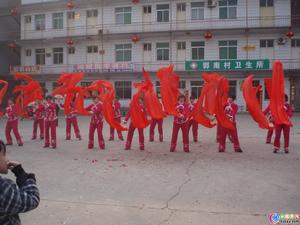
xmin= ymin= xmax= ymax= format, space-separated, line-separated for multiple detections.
xmin=219 ymin=124 xmax=240 ymax=151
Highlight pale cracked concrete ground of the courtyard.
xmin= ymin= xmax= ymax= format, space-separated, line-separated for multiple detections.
xmin=0 ymin=115 xmax=300 ymax=225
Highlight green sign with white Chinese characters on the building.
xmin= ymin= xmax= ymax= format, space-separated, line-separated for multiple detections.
xmin=185 ymin=59 xmax=270 ymax=71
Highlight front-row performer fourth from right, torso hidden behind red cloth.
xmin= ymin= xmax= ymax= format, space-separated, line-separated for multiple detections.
xmin=123 ymin=98 xmax=146 ymax=151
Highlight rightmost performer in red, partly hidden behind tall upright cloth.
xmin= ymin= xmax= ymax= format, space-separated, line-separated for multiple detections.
xmin=273 ymin=95 xmax=293 ymax=153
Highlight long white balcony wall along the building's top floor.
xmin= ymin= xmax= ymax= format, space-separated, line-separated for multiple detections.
xmin=21 ymin=16 xmax=291 ymax=40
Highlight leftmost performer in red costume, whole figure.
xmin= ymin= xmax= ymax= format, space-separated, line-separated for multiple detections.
xmin=5 ymin=99 xmax=23 ymax=146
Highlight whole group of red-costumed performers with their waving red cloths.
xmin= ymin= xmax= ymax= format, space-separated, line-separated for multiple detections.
xmin=0 ymin=61 xmax=292 ymax=153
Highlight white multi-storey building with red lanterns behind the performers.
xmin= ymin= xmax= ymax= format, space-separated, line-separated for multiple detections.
xmin=12 ymin=0 xmax=300 ymax=111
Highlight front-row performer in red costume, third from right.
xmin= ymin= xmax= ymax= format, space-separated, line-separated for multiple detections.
xmin=170 ymin=95 xmax=190 ymax=152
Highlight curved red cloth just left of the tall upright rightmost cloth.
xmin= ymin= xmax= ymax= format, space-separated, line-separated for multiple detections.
xmin=243 ymin=75 xmax=269 ymax=129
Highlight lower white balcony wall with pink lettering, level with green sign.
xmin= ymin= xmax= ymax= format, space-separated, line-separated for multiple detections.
xmin=10 ymin=59 xmax=300 ymax=74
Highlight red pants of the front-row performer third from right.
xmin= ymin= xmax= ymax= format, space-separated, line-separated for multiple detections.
xmin=171 ymin=122 xmax=189 ymax=151
